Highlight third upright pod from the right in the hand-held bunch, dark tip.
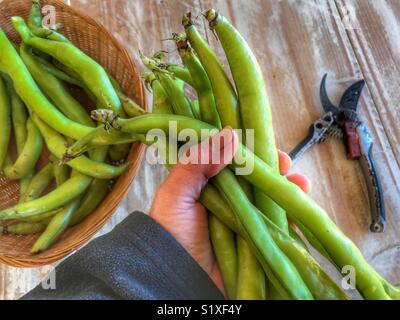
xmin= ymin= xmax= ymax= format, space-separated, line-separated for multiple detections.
xmin=176 ymin=37 xmax=221 ymax=128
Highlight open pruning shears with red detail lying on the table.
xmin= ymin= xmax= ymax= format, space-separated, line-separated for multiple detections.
xmin=290 ymin=74 xmax=386 ymax=233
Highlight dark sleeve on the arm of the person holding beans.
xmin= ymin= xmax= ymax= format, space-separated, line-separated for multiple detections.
xmin=22 ymin=212 xmax=223 ymax=300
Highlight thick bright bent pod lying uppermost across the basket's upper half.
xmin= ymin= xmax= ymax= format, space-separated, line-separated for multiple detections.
xmin=12 ymin=17 xmax=125 ymax=117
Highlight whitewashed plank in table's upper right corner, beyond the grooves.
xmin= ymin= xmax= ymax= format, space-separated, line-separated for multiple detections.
xmin=337 ymin=0 xmax=400 ymax=161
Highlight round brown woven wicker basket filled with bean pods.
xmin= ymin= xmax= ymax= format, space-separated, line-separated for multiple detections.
xmin=0 ymin=0 xmax=146 ymax=267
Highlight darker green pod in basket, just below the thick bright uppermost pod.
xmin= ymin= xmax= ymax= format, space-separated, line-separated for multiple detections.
xmin=20 ymin=43 xmax=94 ymax=127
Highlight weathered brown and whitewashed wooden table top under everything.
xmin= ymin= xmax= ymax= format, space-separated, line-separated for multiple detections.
xmin=0 ymin=0 xmax=400 ymax=299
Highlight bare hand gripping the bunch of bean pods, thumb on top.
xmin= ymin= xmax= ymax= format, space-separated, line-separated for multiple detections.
xmin=150 ymin=128 xmax=311 ymax=292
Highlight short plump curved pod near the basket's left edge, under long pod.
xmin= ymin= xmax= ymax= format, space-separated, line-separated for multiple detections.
xmin=4 ymin=118 xmax=43 ymax=180
